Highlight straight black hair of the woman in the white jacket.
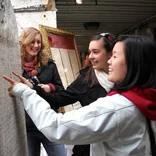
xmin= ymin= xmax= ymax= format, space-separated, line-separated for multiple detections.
xmin=114 ymin=35 xmax=156 ymax=91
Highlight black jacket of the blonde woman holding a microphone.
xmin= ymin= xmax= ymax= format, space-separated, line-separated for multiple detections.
xmin=22 ymin=59 xmax=64 ymax=130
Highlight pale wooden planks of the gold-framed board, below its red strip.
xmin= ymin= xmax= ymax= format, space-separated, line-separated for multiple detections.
xmin=51 ymin=48 xmax=81 ymax=113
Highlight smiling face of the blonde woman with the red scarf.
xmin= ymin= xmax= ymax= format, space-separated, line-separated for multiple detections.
xmin=25 ymin=34 xmax=42 ymax=59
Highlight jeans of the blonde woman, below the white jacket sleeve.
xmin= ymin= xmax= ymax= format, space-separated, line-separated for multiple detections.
xmin=27 ymin=130 xmax=66 ymax=156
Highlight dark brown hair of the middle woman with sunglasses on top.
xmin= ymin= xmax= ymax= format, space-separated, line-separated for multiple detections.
xmin=83 ymin=33 xmax=114 ymax=88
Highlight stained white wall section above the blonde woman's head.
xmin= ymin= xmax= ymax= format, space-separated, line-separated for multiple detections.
xmin=11 ymin=0 xmax=57 ymax=35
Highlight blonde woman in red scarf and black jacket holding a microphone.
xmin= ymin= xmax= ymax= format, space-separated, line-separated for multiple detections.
xmin=20 ymin=27 xmax=65 ymax=156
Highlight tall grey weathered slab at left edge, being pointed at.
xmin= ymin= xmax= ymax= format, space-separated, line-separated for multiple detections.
xmin=0 ymin=0 xmax=27 ymax=156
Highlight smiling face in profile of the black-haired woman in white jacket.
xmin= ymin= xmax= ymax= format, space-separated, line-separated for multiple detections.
xmin=108 ymin=42 xmax=127 ymax=84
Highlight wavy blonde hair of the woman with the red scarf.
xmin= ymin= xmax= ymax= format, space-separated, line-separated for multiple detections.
xmin=19 ymin=27 xmax=48 ymax=65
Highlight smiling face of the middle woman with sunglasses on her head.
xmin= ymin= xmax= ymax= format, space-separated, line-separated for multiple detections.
xmin=89 ymin=39 xmax=111 ymax=73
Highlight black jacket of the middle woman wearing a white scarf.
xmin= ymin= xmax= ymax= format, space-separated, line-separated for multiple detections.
xmin=34 ymin=67 xmax=107 ymax=109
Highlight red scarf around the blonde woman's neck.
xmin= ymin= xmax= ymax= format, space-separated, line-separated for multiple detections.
xmin=22 ymin=57 xmax=38 ymax=77
